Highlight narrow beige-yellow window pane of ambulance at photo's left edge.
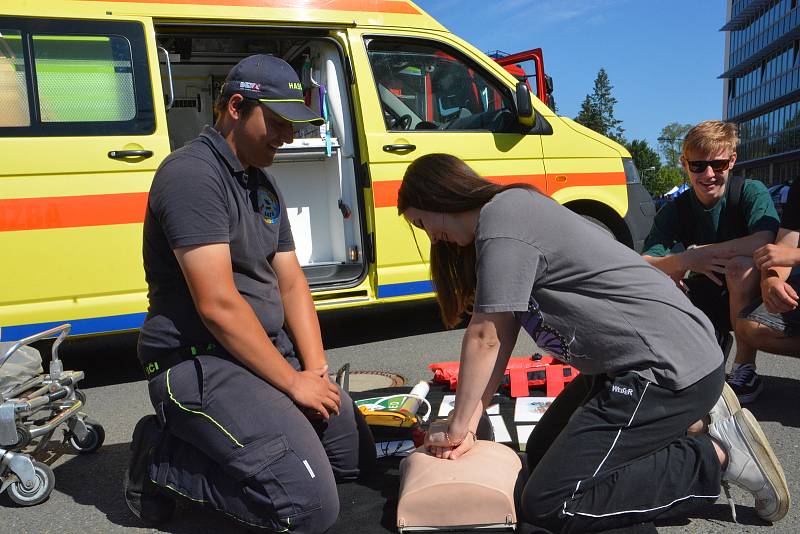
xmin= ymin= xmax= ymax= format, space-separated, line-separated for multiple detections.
xmin=0 ymin=29 xmax=31 ymax=127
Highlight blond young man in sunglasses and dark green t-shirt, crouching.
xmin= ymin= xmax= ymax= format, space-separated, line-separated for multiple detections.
xmin=643 ymin=121 xmax=779 ymax=404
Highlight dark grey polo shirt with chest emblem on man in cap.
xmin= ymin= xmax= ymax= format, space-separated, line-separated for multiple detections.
xmin=138 ymin=126 xmax=294 ymax=368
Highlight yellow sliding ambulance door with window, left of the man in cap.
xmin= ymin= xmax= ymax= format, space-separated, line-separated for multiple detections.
xmin=0 ymin=14 xmax=169 ymax=340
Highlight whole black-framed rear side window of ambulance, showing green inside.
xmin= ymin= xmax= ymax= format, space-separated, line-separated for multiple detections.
xmin=0 ymin=16 xmax=156 ymax=137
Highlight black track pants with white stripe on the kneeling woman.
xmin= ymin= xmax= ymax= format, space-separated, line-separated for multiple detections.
xmin=521 ymin=368 xmax=724 ymax=532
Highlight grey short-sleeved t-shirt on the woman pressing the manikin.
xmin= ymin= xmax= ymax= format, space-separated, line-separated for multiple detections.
xmin=475 ymin=189 xmax=723 ymax=390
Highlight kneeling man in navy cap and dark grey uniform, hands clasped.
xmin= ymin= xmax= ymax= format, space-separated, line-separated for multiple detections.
xmin=125 ymin=55 xmax=375 ymax=533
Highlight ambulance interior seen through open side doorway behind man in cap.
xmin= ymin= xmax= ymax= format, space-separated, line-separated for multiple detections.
xmin=156 ymin=30 xmax=366 ymax=290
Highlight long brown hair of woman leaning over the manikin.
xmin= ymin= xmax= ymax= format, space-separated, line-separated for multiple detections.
xmin=397 ymin=154 xmax=538 ymax=328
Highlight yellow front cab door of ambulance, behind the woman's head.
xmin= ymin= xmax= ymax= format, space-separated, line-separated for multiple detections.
xmin=348 ymin=29 xmax=545 ymax=298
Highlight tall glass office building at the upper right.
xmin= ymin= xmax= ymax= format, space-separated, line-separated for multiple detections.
xmin=720 ymin=0 xmax=800 ymax=185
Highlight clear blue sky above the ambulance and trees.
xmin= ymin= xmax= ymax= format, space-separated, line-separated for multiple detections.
xmin=415 ymin=0 xmax=727 ymax=159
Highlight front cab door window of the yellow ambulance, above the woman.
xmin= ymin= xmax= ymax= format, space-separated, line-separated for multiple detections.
xmin=367 ymin=39 xmax=517 ymax=132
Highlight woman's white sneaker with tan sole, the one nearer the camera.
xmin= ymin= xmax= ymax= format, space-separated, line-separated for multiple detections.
xmin=708 ymin=409 xmax=791 ymax=523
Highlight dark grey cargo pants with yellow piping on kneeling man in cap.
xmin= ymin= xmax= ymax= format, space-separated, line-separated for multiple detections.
xmin=149 ymin=355 xmax=375 ymax=533
